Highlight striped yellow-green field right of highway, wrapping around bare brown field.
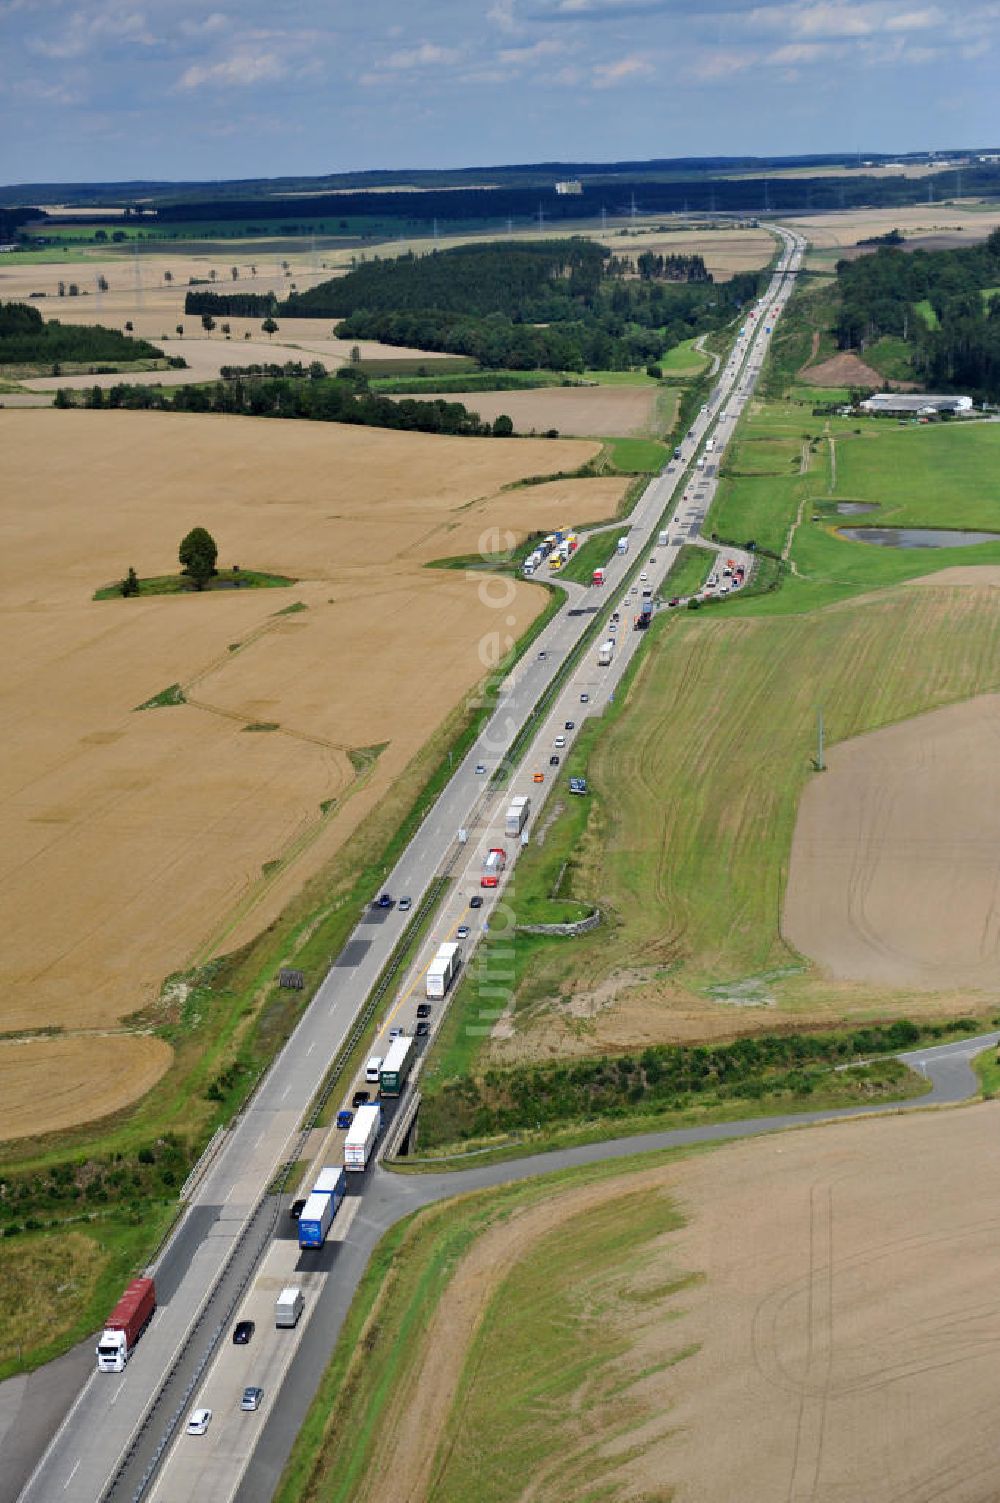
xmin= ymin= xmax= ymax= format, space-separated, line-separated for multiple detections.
xmin=466 ymin=574 xmax=1000 ymax=1046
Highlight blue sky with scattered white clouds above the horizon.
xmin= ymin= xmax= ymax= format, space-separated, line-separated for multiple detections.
xmin=0 ymin=0 xmax=1000 ymax=183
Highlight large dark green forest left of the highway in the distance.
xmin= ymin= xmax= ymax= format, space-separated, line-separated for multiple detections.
xmin=280 ymin=239 xmax=765 ymax=371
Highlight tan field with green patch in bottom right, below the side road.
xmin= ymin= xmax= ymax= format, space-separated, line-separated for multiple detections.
xmin=345 ymin=1103 xmax=1000 ymax=1503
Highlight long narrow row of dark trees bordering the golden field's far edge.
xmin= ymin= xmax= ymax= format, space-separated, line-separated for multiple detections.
xmin=56 ymin=377 xmax=513 ymax=437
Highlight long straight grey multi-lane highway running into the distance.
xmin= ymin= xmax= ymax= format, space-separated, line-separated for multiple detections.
xmin=13 ymin=230 xmax=805 ymax=1503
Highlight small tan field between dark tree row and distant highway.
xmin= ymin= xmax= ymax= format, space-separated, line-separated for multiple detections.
xmin=384 ymin=386 xmax=666 ymax=437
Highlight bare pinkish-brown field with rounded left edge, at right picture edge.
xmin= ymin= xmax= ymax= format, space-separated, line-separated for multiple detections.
xmin=782 ymin=694 xmax=1000 ymax=992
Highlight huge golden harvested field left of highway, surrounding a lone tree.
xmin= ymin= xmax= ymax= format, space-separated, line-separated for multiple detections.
xmin=0 ymin=410 xmax=616 ymax=1136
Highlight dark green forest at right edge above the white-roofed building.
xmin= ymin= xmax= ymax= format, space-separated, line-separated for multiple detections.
xmin=835 ymin=230 xmax=1000 ymax=401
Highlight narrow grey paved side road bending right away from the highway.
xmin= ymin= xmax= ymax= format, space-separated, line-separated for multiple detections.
xmin=236 ymin=1033 xmax=1000 ymax=1503
